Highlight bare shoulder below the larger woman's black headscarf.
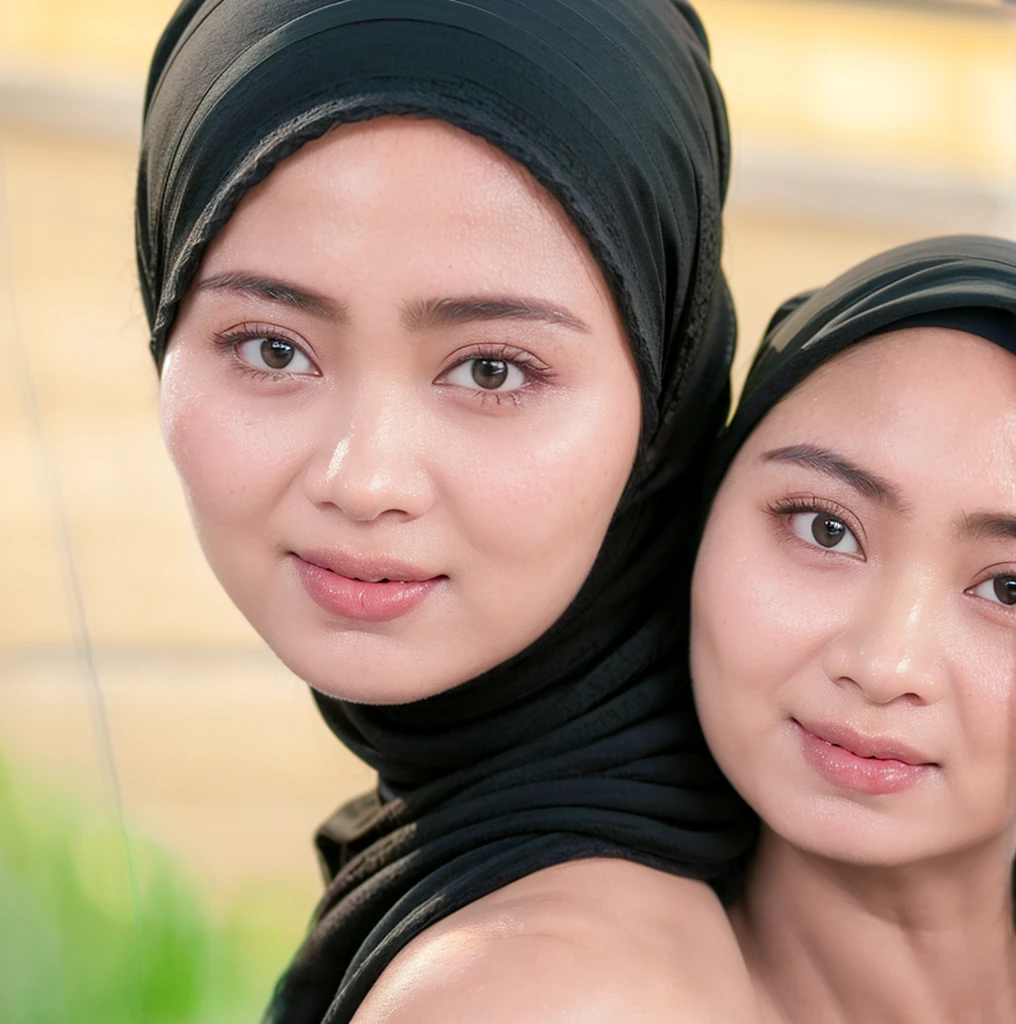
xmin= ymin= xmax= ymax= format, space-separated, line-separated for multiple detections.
xmin=353 ymin=858 xmax=759 ymax=1024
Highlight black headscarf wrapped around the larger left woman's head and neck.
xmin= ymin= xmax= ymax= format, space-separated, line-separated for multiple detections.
xmin=137 ymin=0 xmax=750 ymax=1024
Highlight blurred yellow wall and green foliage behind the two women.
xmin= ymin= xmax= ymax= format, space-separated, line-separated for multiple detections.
xmin=0 ymin=0 xmax=1016 ymax=1024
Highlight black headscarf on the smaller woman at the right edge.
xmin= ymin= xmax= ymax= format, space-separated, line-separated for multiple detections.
xmin=710 ymin=236 xmax=1016 ymax=493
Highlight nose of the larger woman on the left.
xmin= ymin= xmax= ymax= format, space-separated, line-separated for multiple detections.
xmin=304 ymin=392 xmax=434 ymax=522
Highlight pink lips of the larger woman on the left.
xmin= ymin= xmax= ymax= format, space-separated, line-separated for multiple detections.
xmin=293 ymin=551 xmax=448 ymax=623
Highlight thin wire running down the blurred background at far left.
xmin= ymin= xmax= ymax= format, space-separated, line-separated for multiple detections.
xmin=0 ymin=137 xmax=143 ymax=998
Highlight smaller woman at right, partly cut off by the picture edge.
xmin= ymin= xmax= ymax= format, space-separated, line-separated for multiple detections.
xmin=691 ymin=238 xmax=1016 ymax=1024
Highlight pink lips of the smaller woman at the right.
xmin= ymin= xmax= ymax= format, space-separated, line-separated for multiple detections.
xmin=792 ymin=719 xmax=938 ymax=794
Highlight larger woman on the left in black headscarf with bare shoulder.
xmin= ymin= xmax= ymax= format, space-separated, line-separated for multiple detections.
xmin=137 ymin=0 xmax=750 ymax=1024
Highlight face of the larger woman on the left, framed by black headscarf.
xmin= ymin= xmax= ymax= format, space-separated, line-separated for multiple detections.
xmin=161 ymin=118 xmax=641 ymax=703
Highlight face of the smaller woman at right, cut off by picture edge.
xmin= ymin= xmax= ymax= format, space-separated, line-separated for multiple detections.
xmin=691 ymin=328 xmax=1016 ymax=865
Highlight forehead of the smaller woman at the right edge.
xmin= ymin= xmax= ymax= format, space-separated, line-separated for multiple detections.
xmin=738 ymin=328 xmax=1016 ymax=505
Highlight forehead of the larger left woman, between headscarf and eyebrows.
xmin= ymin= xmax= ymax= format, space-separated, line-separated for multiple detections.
xmin=202 ymin=117 xmax=595 ymax=287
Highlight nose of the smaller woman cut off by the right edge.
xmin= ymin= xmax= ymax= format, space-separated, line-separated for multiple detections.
xmin=823 ymin=570 xmax=947 ymax=705
